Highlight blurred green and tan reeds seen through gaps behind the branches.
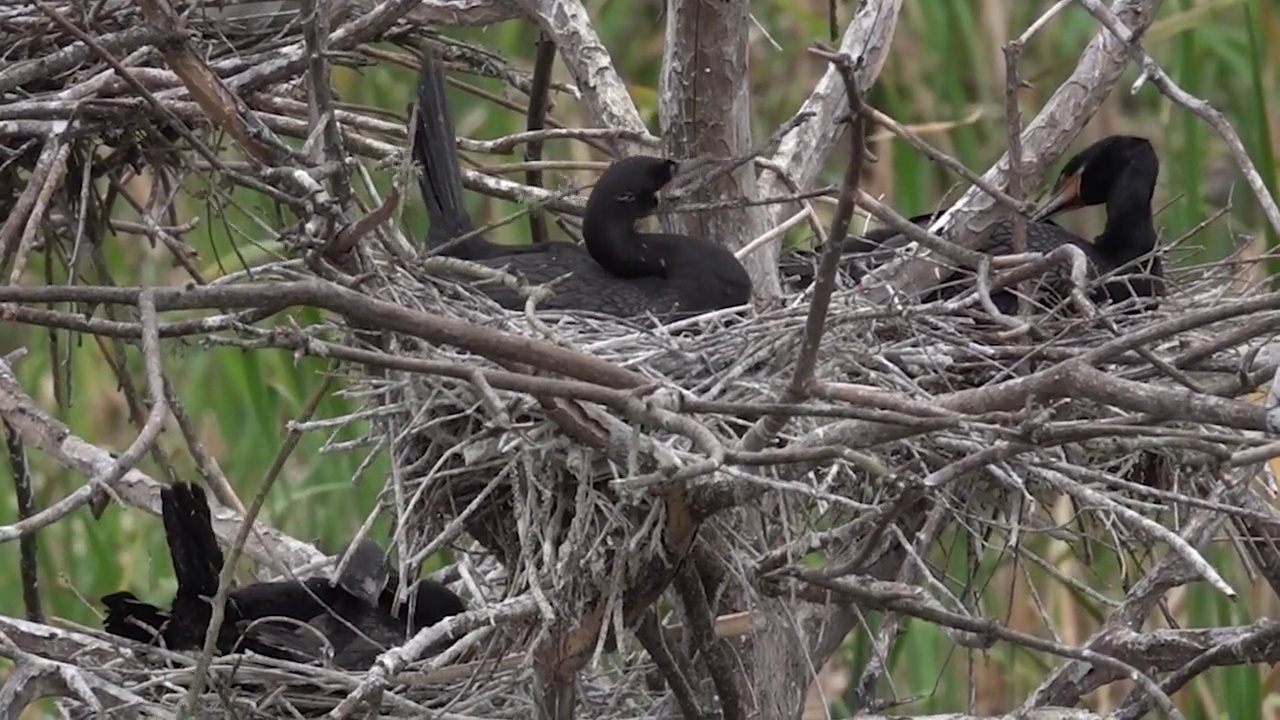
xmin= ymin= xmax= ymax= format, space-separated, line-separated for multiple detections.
xmin=0 ymin=0 xmax=1280 ymax=719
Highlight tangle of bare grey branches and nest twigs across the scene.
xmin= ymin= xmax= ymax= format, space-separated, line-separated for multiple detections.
xmin=0 ymin=0 xmax=1280 ymax=719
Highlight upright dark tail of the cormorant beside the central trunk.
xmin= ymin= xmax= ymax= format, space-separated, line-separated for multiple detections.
xmin=413 ymin=54 xmax=476 ymax=259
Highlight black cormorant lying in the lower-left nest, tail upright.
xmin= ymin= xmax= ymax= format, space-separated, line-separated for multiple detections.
xmin=102 ymin=483 xmax=465 ymax=667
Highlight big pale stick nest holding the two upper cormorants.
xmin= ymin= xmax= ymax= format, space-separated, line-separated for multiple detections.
xmin=384 ymin=243 xmax=1275 ymax=591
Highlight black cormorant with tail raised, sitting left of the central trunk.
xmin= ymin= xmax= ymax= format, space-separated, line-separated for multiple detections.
xmin=413 ymin=56 xmax=751 ymax=318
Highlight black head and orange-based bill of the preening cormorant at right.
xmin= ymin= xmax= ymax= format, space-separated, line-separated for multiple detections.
xmin=1032 ymin=135 xmax=1160 ymax=220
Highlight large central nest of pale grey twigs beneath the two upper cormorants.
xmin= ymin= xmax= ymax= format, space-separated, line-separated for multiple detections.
xmin=366 ymin=244 xmax=1275 ymax=716
